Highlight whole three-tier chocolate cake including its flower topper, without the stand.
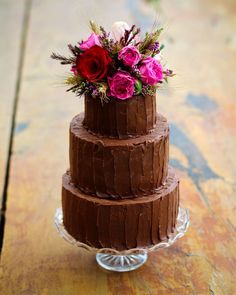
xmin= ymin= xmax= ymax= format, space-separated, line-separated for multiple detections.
xmin=52 ymin=22 xmax=179 ymax=250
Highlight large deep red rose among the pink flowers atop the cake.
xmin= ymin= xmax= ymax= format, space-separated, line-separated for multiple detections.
xmin=76 ymin=45 xmax=112 ymax=82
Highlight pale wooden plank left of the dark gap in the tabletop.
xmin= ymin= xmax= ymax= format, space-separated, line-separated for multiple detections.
xmin=0 ymin=1 xmax=24 ymax=213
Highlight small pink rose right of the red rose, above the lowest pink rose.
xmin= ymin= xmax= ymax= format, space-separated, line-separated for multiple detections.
xmin=118 ymin=45 xmax=141 ymax=67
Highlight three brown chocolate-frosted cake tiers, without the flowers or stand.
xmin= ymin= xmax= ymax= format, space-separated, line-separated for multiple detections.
xmin=62 ymin=95 xmax=179 ymax=250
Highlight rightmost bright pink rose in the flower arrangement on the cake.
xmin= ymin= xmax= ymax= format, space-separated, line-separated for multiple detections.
xmin=139 ymin=57 xmax=163 ymax=85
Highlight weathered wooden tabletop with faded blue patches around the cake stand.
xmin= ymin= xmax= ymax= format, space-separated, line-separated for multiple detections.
xmin=0 ymin=0 xmax=236 ymax=295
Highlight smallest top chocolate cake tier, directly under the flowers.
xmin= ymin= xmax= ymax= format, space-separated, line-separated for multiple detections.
xmin=83 ymin=95 xmax=156 ymax=139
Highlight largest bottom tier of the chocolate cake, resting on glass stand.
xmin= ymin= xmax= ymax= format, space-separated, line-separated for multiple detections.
xmin=62 ymin=169 xmax=179 ymax=250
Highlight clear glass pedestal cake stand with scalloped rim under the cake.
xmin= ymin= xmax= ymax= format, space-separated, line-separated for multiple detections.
xmin=55 ymin=207 xmax=189 ymax=272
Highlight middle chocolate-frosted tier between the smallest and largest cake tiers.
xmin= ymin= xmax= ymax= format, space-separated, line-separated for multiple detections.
xmin=70 ymin=114 xmax=169 ymax=199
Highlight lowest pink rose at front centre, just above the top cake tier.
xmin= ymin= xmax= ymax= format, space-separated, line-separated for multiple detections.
xmin=107 ymin=71 xmax=136 ymax=99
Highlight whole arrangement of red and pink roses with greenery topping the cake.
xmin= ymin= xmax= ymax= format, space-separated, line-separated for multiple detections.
xmin=51 ymin=21 xmax=174 ymax=101
